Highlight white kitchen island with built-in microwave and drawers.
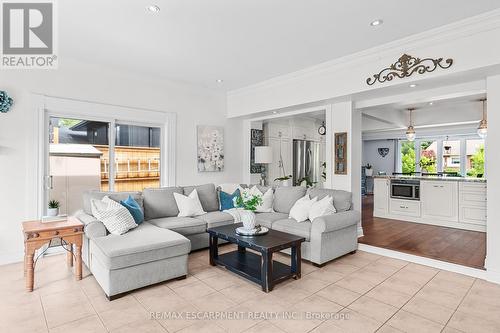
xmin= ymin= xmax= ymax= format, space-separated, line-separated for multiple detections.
xmin=373 ymin=176 xmax=487 ymax=232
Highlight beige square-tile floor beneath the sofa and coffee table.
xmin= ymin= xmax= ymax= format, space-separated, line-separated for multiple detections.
xmin=0 ymin=245 xmax=500 ymax=333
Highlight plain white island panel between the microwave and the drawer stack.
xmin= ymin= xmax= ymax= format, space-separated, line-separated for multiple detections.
xmin=420 ymin=180 xmax=458 ymax=222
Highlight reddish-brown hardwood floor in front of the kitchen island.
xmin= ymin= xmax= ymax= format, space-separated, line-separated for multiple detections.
xmin=359 ymin=195 xmax=486 ymax=269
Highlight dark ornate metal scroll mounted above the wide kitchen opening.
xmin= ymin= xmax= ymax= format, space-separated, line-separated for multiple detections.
xmin=366 ymin=53 xmax=453 ymax=86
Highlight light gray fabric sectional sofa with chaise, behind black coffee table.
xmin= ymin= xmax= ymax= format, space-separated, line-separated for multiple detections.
xmin=76 ymin=184 xmax=361 ymax=299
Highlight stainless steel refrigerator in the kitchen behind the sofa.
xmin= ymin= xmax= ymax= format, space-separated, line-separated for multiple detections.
xmin=293 ymin=140 xmax=321 ymax=185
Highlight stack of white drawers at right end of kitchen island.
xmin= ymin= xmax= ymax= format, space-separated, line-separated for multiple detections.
xmin=459 ymin=183 xmax=487 ymax=226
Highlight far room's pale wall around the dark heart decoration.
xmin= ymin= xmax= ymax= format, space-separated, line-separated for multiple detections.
xmin=363 ymin=140 xmax=396 ymax=175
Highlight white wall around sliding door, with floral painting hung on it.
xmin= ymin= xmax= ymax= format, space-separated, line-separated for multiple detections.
xmin=0 ymin=58 xmax=243 ymax=264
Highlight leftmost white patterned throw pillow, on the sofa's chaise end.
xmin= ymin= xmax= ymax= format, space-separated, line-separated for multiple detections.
xmin=90 ymin=196 xmax=137 ymax=235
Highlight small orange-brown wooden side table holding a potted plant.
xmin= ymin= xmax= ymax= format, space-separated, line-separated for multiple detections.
xmin=23 ymin=217 xmax=83 ymax=291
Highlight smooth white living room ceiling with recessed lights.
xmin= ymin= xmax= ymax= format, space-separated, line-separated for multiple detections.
xmin=58 ymin=0 xmax=500 ymax=90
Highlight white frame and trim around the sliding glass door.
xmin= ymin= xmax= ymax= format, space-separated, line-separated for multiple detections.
xmin=36 ymin=94 xmax=177 ymax=218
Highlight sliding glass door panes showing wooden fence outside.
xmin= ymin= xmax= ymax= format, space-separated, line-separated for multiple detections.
xmin=44 ymin=116 xmax=162 ymax=215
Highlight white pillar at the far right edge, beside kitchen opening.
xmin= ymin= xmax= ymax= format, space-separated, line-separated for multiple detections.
xmin=486 ymin=75 xmax=500 ymax=283
